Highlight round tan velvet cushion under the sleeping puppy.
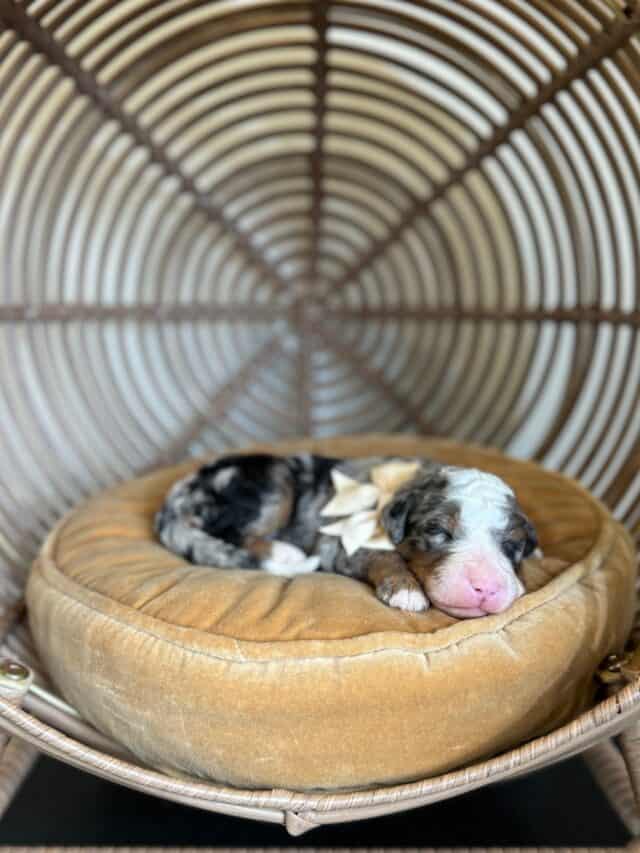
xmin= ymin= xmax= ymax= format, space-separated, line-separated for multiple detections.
xmin=27 ymin=437 xmax=635 ymax=790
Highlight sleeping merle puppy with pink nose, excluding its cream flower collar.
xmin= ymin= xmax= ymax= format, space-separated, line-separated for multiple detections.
xmin=155 ymin=454 xmax=537 ymax=618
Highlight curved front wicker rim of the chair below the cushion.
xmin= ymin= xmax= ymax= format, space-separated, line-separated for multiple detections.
xmin=0 ymin=656 xmax=640 ymax=828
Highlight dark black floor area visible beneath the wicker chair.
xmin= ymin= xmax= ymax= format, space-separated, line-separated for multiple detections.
xmin=0 ymin=758 xmax=628 ymax=847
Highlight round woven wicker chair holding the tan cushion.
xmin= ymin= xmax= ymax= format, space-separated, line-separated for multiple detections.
xmin=0 ymin=0 xmax=640 ymax=835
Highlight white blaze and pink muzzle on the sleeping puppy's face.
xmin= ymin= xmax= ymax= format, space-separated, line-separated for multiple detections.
xmin=426 ymin=467 xmax=525 ymax=617
